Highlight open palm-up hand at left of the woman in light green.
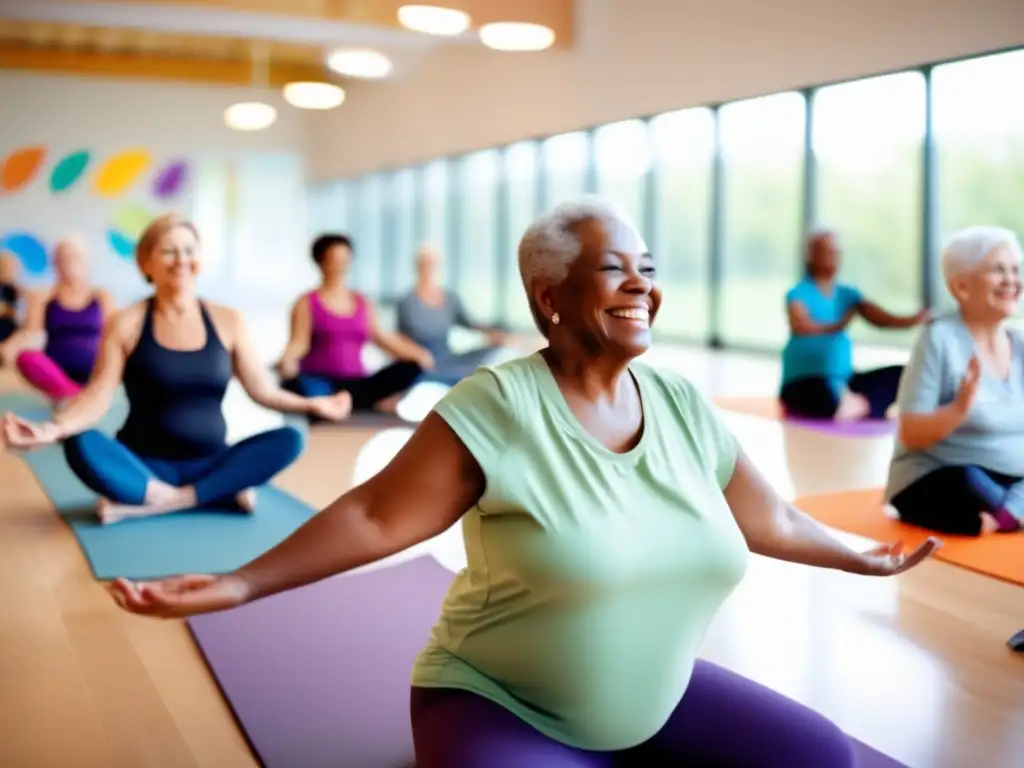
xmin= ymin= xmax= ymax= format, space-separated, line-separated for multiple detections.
xmin=108 ymin=574 xmax=252 ymax=618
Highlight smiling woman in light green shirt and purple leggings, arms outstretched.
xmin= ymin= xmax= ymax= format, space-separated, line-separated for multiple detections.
xmin=105 ymin=199 xmax=935 ymax=768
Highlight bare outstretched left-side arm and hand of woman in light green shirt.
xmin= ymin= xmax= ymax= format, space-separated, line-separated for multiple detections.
xmin=112 ymin=413 xmax=484 ymax=617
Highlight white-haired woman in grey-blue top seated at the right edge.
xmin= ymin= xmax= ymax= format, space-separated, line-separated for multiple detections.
xmin=886 ymin=227 xmax=1024 ymax=536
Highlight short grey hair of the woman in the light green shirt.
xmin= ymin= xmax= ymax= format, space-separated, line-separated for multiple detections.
xmin=519 ymin=195 xmax=636 ymax=338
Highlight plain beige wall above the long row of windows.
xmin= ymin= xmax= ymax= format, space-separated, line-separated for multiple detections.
xmin=309 ymin=0 xmax=1024 ymax=180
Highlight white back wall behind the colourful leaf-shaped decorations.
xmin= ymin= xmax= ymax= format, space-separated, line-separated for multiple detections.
xmin=0 ymin=73 xmax=312 ymax=305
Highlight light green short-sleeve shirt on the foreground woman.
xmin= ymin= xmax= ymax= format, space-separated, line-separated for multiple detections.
xmin=413 ymin=354 xmax=748 ymax=751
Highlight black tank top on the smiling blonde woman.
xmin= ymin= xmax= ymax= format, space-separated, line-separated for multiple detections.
xmin=118 ymin=299 xmax=233 ymax=460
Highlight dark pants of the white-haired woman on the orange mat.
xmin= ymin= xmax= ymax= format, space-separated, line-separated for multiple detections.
xmin=892 ymin=466 xmax=1021 ymax=536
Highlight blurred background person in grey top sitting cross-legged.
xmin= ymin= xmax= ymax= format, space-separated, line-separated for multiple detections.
xmin=398 ymin=246 xmax=506 ymax=386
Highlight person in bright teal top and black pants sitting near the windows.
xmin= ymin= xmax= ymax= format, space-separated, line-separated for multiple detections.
xmin=779 ymin=230 xmax=928 ymax=421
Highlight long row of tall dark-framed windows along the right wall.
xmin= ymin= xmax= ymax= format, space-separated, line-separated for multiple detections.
xmin=323 ymin=49 xmax=1024 ymax=350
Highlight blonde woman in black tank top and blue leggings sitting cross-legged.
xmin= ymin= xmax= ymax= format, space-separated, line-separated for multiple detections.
xmin=4 ymin=215 xmax=351 ymax=523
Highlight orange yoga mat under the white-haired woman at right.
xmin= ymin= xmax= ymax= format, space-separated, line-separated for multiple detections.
xmin=795 ymin=490 xmax=1024 ymax=586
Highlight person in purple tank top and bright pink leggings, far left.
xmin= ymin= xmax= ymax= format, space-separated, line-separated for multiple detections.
xmin=4 ymin=239 xmax=115 ymax=402
